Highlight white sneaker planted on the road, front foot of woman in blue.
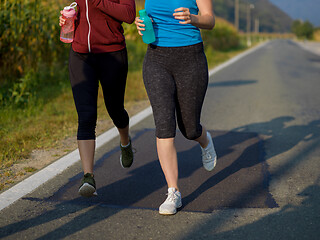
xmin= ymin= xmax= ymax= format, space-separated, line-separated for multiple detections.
xmin=159 ymin=188 xmax=182 ymax=215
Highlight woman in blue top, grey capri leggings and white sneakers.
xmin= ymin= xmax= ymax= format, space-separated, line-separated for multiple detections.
xmin=135 ymin=0 xmax=217 ymax=215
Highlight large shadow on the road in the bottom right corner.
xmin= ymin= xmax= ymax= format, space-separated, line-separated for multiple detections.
xmin=180 ymin=182 xmax=320 ymax=240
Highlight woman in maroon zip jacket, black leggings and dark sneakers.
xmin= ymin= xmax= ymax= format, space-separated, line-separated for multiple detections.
xmin=60 ymin=0 xmax=136 ymax=197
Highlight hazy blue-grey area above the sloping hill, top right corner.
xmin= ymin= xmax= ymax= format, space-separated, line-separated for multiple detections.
xmin=269 ymin=0 xmax=320 ymax=27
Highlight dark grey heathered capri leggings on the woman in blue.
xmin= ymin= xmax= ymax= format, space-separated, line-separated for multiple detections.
xmin=143 ymin=43 xmax=209 ymax=140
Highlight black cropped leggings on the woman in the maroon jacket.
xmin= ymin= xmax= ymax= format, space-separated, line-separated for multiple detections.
xmin=69 ymin=48 xmax=129 ymax=140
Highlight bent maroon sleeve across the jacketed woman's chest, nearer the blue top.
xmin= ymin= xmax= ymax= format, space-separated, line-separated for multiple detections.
xmin=89 ymin=0 xmax=136 ymax=23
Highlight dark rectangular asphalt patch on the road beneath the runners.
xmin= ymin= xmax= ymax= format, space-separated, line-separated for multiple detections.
xmin=48 ymin=129 xmax=277 ymax=212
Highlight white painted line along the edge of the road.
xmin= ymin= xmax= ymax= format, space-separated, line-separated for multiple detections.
xmin=0 ymin=43 xmax=266 ymax=211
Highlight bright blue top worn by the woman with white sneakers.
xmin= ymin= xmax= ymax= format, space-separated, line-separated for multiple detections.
xmin=145 ymin=0 xmax=202 ymax=47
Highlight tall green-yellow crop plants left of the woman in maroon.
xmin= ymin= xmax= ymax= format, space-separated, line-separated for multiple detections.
xmin=0 ymin=0 xmax=67 ymax=106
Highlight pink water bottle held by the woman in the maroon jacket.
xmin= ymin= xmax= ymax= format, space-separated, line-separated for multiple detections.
xmin=60 ymin=2 xmax=77 ymax=43
